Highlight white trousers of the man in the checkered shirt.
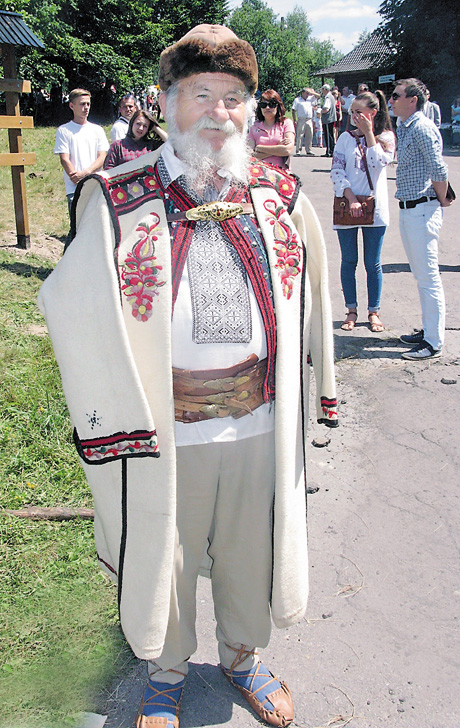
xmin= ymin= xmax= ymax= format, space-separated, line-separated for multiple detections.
xmin=399 ymin=200 xmax=446 ymax=350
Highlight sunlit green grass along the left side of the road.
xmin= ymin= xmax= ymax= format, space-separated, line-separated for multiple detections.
xmin=0 ymin=129 xmax=135 ymax=728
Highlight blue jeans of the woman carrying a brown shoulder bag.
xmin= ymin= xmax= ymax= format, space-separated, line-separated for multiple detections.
xmin=337 ymin=225 xmax=386 ymax=313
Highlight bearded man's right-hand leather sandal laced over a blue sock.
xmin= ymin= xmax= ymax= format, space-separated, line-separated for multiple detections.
xmin=220 ymin=645 xmax=294 ymax=728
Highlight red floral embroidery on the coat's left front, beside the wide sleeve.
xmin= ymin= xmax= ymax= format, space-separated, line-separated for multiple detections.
xmin=121 ymin=212 xmax=166 ymax=321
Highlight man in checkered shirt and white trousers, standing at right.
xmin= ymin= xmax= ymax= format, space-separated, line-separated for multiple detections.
xmin=390 ymin=78 xmax=452 ymax=361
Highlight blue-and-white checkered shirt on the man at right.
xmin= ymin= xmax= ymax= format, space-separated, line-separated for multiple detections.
xmin=395 ymin=111 xmax=447 ymax=201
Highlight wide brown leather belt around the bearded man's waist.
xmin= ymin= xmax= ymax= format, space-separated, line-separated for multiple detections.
xmin=173 ymin=354 xmax=267 ymax=423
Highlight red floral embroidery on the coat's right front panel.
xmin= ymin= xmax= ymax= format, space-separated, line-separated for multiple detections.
xmin=264 ymin=200 xmax=302 ymax=300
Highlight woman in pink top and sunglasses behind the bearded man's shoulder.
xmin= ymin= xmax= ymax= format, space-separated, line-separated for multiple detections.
xmin=248 ymin=89 xmax=295 ymax=169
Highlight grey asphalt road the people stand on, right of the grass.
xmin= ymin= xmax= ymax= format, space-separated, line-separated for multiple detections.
xmin=95 ymin=145 xmax=460 ymax=728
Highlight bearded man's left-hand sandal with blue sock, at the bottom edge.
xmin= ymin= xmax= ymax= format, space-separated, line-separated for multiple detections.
xmin=136 ymin=673 xmax=185 ymax=728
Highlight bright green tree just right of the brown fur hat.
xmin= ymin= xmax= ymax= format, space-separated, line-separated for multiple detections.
xmin=229 ymin=0 xmax=337 ymax=105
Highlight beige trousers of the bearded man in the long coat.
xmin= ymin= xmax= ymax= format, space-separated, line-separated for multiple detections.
xmin=148 ymin=432 xmax=275 ymax=683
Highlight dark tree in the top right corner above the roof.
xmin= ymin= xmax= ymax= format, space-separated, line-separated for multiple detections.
xmin=378 ymin=0 xmax=460 ymax=111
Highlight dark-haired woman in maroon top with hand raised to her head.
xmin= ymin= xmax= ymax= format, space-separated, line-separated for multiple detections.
xmin=104 ymin=110 xmax=168 ymax=169
